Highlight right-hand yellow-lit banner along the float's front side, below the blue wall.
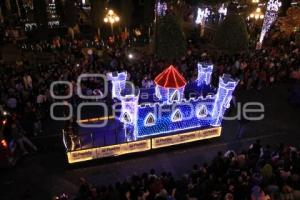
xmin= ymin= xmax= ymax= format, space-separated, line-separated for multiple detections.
xmin=152 ymin=127 xmax=221 ymax=149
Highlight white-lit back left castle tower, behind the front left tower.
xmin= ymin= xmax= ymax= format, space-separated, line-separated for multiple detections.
xmin=106 ymin=72 xmax=127 ymax=99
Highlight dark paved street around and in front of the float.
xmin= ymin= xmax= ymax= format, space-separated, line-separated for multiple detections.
xmin=0 ymin=84 xmax=300 ymax=200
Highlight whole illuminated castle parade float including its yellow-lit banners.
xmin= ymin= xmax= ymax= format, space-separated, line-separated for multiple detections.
xmin=67 ymin=63 xmax=238 ymax=163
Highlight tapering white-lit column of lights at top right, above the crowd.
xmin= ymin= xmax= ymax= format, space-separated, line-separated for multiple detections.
xmin=259 ymin=0 xmax=281 ymax=44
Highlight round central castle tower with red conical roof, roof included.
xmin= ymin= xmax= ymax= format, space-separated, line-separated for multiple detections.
xmin=154 ymin=65 xmax=186 ymax=102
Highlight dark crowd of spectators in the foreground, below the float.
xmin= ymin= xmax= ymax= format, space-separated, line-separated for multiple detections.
xmin=55 ymin=140 xmax=300 ymax=200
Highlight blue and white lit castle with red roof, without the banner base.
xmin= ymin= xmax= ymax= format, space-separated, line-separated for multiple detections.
xmin=110 ymin=64 xmax=237 ymax=141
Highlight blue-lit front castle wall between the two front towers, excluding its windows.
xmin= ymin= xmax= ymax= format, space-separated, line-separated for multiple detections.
xmin=137 ymin=97 xmax=214 ymax=138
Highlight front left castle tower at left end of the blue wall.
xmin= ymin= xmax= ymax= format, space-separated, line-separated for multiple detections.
xmin=119 ymin=84 xmax=140 ymax=141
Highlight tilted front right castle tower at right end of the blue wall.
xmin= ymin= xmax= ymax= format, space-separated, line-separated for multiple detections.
xmin=212 ymin=74 xmax=238 ymax=126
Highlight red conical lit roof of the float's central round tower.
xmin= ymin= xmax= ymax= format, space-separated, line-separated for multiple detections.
xmin=154 ymin=65 xmax=186 ymax=89
